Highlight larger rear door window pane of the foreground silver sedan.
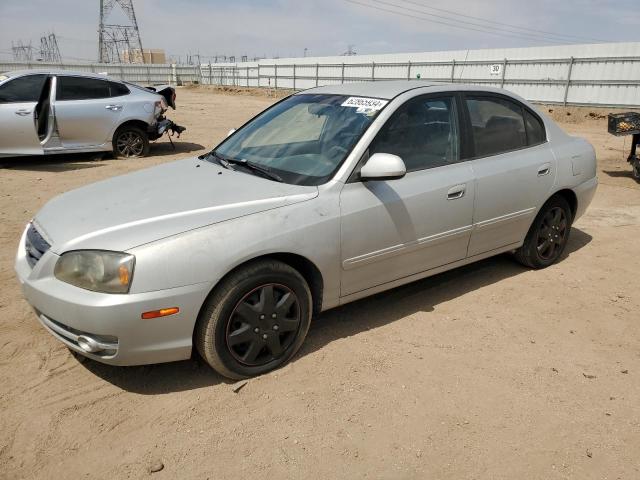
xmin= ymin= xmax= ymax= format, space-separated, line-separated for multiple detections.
xmin=466 ymin=96 xmax=527 ymax=157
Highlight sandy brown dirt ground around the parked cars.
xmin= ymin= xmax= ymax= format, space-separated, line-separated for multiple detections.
xmin=0 ymin=89 xmax=640 ymax=480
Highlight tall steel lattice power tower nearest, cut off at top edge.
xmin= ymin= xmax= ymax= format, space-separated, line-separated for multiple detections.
xmin=98 ymin=0 xmax=144 ymax=63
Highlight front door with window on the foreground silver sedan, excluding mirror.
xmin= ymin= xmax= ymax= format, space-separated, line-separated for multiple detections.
xmin=340 ymin=95 xmax=474 ymax=296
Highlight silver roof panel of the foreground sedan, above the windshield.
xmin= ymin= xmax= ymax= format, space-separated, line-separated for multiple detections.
xmin=297 ymin=79 xmax=522 ymax=100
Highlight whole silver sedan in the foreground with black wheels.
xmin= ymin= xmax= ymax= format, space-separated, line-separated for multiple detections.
xmin=16 ymin=81 xmax=597 ymax=378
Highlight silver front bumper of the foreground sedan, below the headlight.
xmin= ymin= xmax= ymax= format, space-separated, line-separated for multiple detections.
xmin=15 ymin=227 xmax=211 ymax=365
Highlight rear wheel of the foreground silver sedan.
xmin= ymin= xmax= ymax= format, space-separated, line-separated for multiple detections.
xmin=515 ymin=195 xmax=573 ymax=269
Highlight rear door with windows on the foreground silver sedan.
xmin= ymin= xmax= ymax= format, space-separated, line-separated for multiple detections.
xmin=464 ymin=93 xmax=556 ymax=256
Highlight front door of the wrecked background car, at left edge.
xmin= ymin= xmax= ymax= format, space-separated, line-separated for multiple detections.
xmin=0 ymin=74 xmax=47 ymax=156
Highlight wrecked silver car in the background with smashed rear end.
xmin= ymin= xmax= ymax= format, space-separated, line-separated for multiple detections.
xmin=0 ymin=70 xmax=182 ymax=157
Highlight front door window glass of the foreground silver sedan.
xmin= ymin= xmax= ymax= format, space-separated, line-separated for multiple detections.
xmin=369 ymin=96 xmax=460 ymax=172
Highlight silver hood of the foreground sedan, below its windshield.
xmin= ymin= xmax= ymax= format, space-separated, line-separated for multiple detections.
xmin=33 ymin=158 xmax=318 ymax=254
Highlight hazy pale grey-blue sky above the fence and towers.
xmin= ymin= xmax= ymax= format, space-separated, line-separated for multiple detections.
xmin=0 ymin=0 xmax=640 ymax=61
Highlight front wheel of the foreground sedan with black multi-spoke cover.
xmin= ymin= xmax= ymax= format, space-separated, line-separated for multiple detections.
xmin=194 ymin=260 xmax=312 ymax=380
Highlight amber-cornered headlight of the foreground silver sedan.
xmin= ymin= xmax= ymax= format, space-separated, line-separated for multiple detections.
xmin=53 ymin=250 xmax=135 ymax=293
